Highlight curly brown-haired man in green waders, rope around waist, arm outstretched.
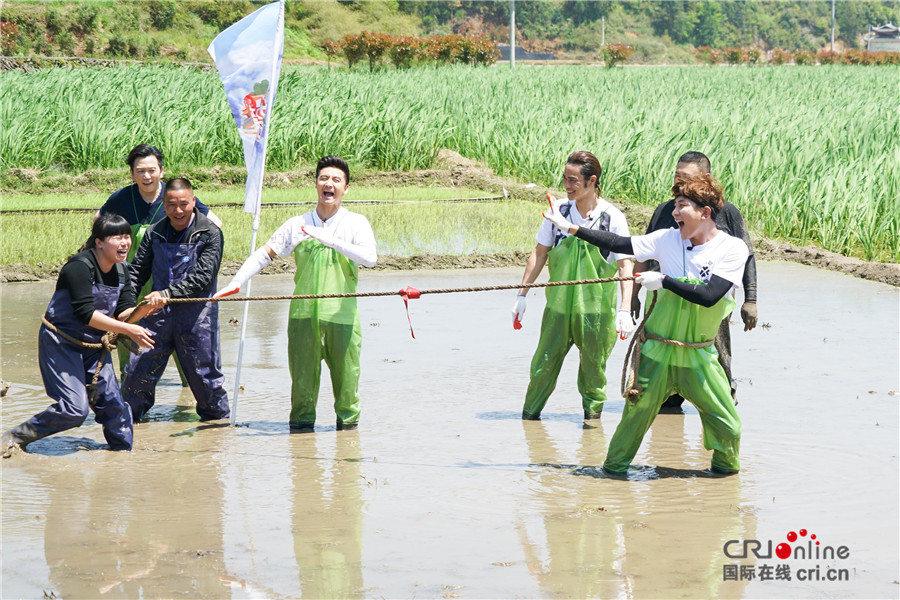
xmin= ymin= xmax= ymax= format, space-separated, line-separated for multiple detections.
xmin=544 ymin=175 xmax=749 ymax=473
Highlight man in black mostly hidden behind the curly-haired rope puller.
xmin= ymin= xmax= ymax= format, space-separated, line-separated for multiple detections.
xmin=632 ymin=152 xmax=757 ymax=412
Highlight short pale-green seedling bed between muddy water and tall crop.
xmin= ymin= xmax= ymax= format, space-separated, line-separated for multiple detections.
xmin=0 ymin=200 xmax=541 ymax=264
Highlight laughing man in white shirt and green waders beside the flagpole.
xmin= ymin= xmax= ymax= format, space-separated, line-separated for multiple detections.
xmin=214 ymin=156 xmax=378 ymax=432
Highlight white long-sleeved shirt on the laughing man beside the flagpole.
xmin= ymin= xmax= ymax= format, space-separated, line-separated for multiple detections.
xmin=266 ymin=207 xmax=378 ymax=267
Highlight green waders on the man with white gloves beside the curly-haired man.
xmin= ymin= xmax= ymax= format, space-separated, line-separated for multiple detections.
xmin=522 ymin=236 xmax=617 ymax=419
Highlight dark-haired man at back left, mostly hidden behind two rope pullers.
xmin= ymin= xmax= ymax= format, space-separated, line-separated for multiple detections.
xmin=94 ymin=144 xmax=222 ymax=387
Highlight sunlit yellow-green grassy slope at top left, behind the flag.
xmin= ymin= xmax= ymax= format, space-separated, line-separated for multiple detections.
xmin=0 ymin=0 xmax=421 ymax=62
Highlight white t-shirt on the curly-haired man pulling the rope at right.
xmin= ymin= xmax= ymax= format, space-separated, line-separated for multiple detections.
xmin=631 ymin=229 xmax=750 ymax=289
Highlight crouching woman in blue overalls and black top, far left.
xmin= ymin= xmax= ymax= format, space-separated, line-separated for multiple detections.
xmin=2 ymin=214 xmax=153 ymax=451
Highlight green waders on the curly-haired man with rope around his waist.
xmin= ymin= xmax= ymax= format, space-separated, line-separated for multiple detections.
xmin=603 ymin=278 xmax=741 ymax=473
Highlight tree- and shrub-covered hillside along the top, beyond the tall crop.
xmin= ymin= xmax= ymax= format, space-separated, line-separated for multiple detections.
xmin=0 ymin=0 xmax=900 ymax=63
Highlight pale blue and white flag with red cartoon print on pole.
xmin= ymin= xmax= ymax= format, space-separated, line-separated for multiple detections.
xmin=208 ymin=0 xmax=284 ymax=214
